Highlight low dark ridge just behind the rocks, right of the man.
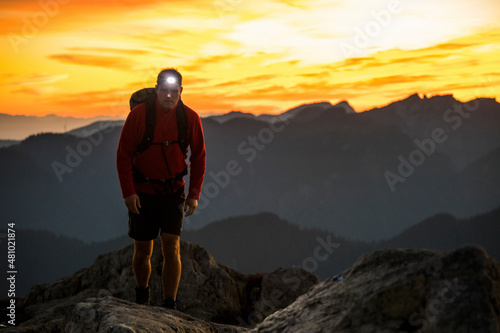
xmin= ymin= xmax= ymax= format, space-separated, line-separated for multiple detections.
xmin=183 ymin=208 xmax=500 ymax=279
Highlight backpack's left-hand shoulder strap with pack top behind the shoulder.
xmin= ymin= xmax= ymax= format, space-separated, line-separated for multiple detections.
xmin=130 ymin=88 xmax=156 ymax=154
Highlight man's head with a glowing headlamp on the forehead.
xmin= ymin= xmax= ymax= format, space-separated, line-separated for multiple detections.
xmin=155 ymin=68 xmax=182 ymax=111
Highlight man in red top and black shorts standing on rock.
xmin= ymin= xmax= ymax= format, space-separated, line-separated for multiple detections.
xmin=116 ymin=69 xmax=206 ymax=309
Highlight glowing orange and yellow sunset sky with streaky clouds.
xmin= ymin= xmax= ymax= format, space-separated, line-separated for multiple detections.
xmin=0 ymin=0 xmax=500 ymax=118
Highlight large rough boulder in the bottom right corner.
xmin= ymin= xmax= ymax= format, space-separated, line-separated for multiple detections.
xmin=251 ymin=246 xmax=500 ymax=333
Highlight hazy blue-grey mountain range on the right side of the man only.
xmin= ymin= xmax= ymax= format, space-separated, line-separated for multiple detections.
xmin=191 ymin=95 xmax=500 ymax=240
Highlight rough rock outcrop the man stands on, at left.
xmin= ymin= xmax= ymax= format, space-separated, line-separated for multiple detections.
xmin=5 ymin=239 xmax=319 ymax=332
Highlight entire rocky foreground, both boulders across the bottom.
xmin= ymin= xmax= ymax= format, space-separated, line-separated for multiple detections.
xmin=4 ymin=242 xmax=500 ymax=333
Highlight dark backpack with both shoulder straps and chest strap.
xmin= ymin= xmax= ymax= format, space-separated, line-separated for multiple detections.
xmin=130 ymin=88 xmax=188 ymax=158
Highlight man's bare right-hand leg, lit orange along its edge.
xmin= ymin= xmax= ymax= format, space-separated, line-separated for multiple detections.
xmin=161 ymin=233 xmax=182 ymax=300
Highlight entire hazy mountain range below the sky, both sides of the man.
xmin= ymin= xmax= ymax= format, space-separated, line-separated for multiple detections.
xmin=0 ymin=94 xmax=500 ymax=242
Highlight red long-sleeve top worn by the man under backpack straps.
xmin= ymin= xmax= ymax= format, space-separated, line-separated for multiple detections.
xmin=116 ymin=99 xmax=206 ymax=200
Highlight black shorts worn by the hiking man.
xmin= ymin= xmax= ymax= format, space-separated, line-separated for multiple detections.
xmin=128 ymin=186 xmax=186 ymax=241
